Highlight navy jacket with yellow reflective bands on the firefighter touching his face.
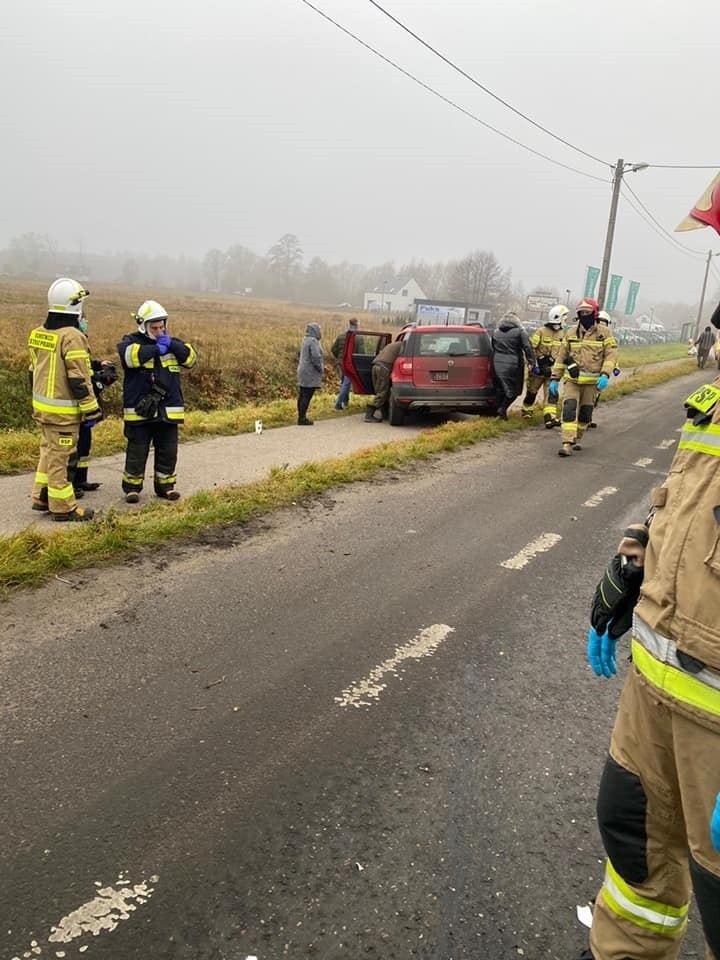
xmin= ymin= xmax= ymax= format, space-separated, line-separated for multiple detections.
xmin=118 ymin=331 xmax=197 ymax=423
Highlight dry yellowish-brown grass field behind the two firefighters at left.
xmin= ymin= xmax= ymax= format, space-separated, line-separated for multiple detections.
xmin=0 ymin=281 xmax=390 ymax=429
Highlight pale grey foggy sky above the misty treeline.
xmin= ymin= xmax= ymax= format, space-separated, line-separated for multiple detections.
xmin=0 ymin=0 xmax=720 ymax=303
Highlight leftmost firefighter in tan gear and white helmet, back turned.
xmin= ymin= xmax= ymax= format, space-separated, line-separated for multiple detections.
xmin=28 ymin=277 xmax=100 ymax=521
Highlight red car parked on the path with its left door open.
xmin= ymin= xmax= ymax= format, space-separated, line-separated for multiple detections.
xmin=343 ymin=324 xmax=497 ymax=427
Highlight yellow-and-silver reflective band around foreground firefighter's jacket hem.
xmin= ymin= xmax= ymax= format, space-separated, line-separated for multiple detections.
xmin=631 ymin=616 xmax=720 ymax=717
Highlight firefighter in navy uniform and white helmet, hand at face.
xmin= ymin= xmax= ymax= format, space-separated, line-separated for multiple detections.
xmin=118 ymin=300 xmax=197 ymax=503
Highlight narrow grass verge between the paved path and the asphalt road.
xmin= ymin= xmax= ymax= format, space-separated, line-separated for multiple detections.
xmin=0 ymin=360 xmax=696 ymax=596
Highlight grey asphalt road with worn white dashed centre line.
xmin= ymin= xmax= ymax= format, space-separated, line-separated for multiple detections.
xmin=0 ymin=373 xmax=703 ymax=960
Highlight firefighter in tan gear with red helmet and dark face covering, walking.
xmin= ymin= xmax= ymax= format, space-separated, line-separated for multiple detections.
xmin=548 ymin=298 xmax=617 ymax=457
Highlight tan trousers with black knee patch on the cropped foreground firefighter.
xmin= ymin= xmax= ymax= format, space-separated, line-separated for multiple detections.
xmin=590 ymin=661 xmax=720 ymax=960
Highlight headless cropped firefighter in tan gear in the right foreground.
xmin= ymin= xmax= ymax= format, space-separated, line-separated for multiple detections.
xmin=583 ymin=313 xmax=720 ymax=960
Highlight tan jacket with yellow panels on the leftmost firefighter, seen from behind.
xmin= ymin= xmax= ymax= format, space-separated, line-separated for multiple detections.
xmin=28 ymin=313 xmax=99 ymax=427
